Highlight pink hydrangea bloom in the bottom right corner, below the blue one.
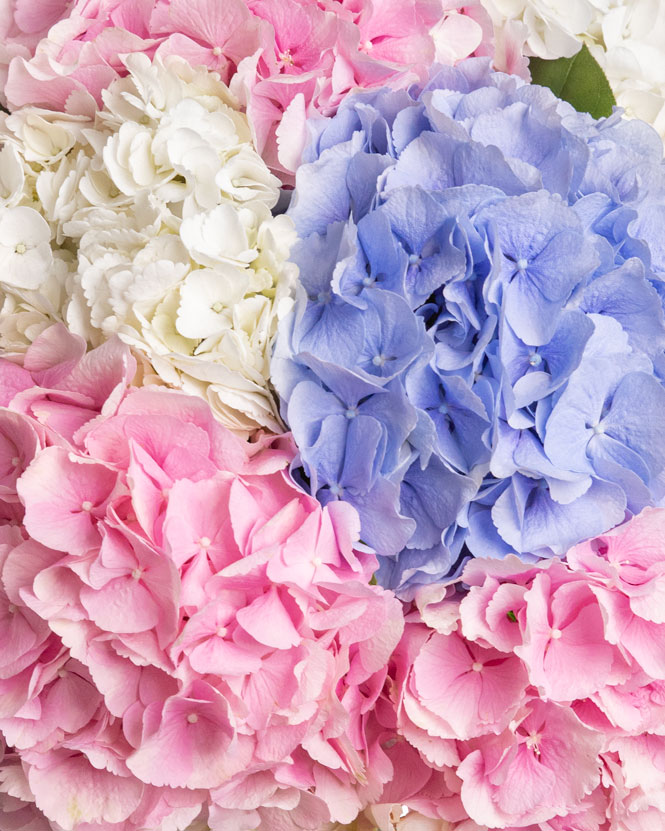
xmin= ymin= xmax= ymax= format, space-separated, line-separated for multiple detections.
xmin=374 ymin=509 xmax=665 ymax=831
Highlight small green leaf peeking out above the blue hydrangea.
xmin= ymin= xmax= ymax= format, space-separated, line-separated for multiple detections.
xmin=529 ymin=44 xmax=616 ymax=118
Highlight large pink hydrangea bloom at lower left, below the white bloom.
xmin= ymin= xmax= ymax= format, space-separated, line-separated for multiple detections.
xmin=0 ymin=325 xmax=403 ymax=831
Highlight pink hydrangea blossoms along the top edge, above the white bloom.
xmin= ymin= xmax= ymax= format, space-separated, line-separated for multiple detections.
xmin=0 ymin=0 xmax=491 ymax=179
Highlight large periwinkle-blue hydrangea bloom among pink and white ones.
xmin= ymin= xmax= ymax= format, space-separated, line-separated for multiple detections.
xmin=272 ymin=58 xmax=665 ymax=596
